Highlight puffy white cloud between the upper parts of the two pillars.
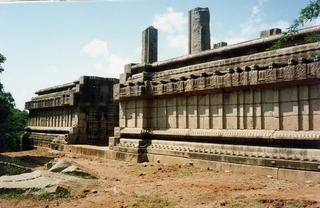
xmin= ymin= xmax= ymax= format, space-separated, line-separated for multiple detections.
xmin=153 ymin=8 xmax=188 ymax=33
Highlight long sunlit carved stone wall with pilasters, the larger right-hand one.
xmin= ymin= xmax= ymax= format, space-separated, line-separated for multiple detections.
xmin=112 ymin=26 xmax=320 ymax=171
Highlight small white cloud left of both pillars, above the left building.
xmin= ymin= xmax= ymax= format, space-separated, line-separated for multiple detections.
xmin=81 ymin=39 xmax=109 ymax=57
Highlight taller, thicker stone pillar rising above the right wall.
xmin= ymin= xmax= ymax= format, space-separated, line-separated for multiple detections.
xmin=189 ymin=7 xmax=210 ymax=54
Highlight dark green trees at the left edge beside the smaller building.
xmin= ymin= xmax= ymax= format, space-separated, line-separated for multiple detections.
xmin=0 ymin=54 xmax=28 ymax=152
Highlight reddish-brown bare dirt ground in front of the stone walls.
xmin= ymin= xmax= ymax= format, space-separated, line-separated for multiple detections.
xmin=0 ymin=149 xmax=320 ymax=208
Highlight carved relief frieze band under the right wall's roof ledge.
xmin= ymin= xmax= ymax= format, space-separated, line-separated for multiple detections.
xmin=117 ymin=59 xmax=320 ymax=98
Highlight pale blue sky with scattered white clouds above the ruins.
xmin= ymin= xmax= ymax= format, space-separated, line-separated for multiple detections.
xmin=0 ymin=0 xmax=320 ymax=109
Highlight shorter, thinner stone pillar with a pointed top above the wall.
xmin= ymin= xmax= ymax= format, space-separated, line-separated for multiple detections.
xmin=141 ymin=26 xmax=158 ymax=63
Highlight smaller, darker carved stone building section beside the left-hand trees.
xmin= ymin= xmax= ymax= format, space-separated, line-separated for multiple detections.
xmin=23 ymin=76 xmax=119 ymax=148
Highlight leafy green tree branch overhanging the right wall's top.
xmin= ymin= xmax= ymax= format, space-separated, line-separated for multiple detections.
xmin=267 ymin=0 xmax=320 ymax=50
